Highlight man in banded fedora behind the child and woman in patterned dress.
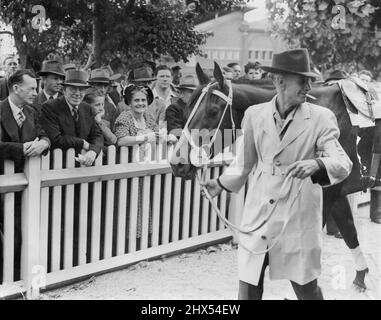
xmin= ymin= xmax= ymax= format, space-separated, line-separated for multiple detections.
xmin=89 ymin=68 xmax=120 ymax=130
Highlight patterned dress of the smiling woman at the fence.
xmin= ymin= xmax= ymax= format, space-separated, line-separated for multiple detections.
xmin=114 ymin=110 xmax=159 ymax=238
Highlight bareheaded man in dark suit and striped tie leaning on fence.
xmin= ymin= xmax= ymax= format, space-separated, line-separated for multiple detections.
xmin=0 ymin=70 xmax=50 ymax=283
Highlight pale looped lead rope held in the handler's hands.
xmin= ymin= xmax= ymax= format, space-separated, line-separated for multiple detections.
xmin=197 ymin=168 xmax=305 ymax=255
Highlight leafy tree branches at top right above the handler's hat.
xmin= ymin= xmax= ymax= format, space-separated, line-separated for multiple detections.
xmin=266 ymin=0 xmax=381 ymax=72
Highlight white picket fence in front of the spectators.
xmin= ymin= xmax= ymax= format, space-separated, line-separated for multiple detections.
xmin=0 ymin=145 xmax=236 ymax=298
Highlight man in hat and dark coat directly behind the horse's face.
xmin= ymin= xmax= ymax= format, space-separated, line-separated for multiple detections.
xmin=165 ymin=75 xmax=197 ymax=137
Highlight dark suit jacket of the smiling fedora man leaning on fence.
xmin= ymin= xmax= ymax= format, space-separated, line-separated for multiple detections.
xmin=40 ymin=96 xmax=103 ymax=155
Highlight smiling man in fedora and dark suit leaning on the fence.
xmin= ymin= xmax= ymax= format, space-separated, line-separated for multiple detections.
xmin=40 ymin=70 xmax=103 ymax=166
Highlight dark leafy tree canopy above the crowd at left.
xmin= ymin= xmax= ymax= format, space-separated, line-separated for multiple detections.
xmin=0 ymin=0 xmax=245 ymax=66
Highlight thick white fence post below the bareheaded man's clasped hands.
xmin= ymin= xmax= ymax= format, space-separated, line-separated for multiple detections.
xmin=21 ymin=157 xmax=42 ymax=299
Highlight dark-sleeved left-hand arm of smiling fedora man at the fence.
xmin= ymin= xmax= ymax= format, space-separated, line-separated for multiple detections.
xmin=40 ymin=103 xmax=84 ymax=150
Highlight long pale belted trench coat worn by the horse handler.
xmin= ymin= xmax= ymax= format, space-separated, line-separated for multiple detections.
xmin=220 ymin=97 xmax=352 ymax=285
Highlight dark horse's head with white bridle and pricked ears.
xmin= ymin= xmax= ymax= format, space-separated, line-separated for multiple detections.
xmin=170 ymin=63 xmax=234 ymax=179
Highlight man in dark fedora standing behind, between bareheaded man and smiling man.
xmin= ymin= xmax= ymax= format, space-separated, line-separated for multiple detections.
xmin=33 ymin=60 xmax=65 ymax=113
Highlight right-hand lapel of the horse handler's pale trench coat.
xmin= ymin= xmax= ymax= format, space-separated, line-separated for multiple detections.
xmin=276 ymin=103 xmax=311 ymax=155
